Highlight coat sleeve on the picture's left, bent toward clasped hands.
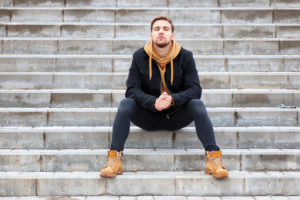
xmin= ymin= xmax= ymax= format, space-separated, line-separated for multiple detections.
xmin=125 ymin=54 xmax=156 ymax=111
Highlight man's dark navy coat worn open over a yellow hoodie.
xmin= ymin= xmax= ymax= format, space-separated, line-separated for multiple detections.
xmin=125 ymin=48 xmax=202 ymax=112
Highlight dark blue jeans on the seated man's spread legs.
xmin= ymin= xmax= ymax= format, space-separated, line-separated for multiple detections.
xmin=110 ymin=98 xmax=220 ymax=151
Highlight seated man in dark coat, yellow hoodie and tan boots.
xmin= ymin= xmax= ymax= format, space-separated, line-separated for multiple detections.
xmin=100 ymin=16 xmax=228 ymax=178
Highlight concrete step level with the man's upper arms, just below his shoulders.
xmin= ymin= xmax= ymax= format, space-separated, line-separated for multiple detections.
xmin=0 ymin=54 xmax=300 ymax=72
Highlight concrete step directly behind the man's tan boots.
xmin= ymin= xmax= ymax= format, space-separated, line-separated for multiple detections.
xmin=0 ymin=149 xmax=300 ymax=172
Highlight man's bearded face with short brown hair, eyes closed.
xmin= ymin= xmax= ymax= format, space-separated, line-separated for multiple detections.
xmin=150 ymin=20 xmax=175 ymax=48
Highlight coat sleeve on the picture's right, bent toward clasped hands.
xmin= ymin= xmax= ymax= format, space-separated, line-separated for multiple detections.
xmin=171 ymin=52 xmax=202 ymax=106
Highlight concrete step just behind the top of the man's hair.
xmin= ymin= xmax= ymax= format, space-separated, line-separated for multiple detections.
xmin=0 ymin=7 xmax=300 ymax=23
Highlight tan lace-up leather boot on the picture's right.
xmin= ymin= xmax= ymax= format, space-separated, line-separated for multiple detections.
xmin=205 ymin=151 xmax=228 ymax=178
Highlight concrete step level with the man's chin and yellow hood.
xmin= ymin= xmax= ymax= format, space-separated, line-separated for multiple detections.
xmin=1 ymin=38 xmax=300 ymax=55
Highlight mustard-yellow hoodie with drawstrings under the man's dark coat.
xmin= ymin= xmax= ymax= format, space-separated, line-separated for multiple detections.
xmin=144 ymin=40 xmax=181 ymax=93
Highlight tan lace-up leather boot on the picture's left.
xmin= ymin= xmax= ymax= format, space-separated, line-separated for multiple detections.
xmin=100 ymin=150 xmax=123 ymax=178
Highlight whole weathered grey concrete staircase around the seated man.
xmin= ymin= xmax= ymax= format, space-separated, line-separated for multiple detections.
xmin=0 ymin=0 xmax=300 ymax=200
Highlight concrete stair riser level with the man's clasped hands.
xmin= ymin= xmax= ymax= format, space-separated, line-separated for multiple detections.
xmin=0 ymin=91 xmax=300 ymax=108
